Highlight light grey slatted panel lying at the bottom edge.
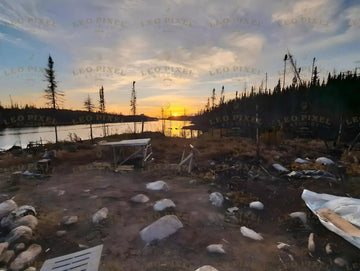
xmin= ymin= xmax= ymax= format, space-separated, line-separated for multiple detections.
xmin=40 ymin=245 xmax=103 ymax=271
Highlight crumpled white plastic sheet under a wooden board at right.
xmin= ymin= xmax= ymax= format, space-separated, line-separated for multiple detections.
xmin=301 ymin=189 xmax=360 ymax=249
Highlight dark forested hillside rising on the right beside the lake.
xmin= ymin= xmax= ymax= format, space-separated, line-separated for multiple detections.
xmin=193 ymin=70 xmax=360 ymax=140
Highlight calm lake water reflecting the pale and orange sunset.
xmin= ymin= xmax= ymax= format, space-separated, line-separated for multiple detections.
xmin=0 ymin=120 xmax=197 ymax=150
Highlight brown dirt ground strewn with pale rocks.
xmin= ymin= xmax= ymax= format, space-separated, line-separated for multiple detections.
xmin=0 ymin=134 xmax=360 ymax=271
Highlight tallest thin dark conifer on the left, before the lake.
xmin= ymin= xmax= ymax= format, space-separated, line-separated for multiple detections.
xmin=44 ymin=55 xmax=64 ymax=143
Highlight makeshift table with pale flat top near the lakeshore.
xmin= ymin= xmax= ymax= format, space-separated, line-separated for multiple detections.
xmin=101 ymin=138 xmax=152 ymax=167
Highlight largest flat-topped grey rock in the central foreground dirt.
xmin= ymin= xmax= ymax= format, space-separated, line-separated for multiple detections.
xmin=140 ymin=215 xmax=184 ymax=243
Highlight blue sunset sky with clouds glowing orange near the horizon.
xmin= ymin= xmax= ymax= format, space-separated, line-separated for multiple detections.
xmin=0 ymin=0 xmax=360 ymax=117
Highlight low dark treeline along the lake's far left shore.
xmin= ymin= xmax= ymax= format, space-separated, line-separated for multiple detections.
xmin=0 ymin=106 xmax=157 ymax=129
